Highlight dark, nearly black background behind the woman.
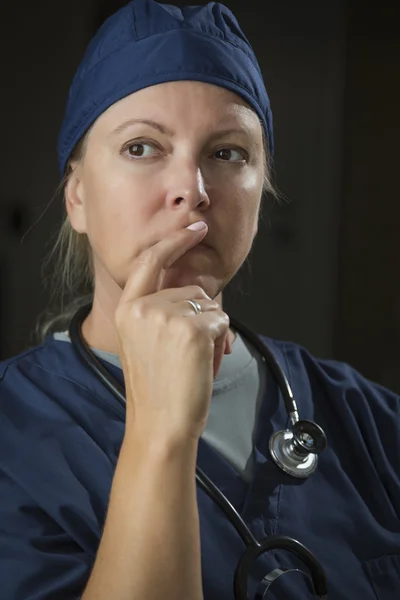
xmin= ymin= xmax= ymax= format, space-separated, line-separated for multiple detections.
xmin=0 ymin=0 xmax=400 ymax=393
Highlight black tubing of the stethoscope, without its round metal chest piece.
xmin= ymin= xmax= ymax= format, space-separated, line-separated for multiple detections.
xmin=69 ymin=305 xmax=327 ymax=600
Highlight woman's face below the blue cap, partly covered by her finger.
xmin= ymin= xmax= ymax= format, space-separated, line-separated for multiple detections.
xmin=66 ymin=81 xmax=264 ymax=298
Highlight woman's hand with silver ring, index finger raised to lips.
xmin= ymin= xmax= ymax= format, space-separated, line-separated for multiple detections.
xmin=115 ymin=226 xmax=230 ymax=439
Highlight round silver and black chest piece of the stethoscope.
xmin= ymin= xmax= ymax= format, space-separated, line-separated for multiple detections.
xmin=269 ymin=421 xmax=326 ymax=479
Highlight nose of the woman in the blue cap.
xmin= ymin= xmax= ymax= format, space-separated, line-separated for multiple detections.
xmin=166 ymin=165 xmax=210 ymax=212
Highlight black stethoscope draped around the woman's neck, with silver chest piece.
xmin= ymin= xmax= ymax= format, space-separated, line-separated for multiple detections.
xmin=69 ymin=305 xmax=327 ymax=600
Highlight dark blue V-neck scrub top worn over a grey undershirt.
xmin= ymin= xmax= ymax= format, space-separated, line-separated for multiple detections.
xmin=0 ymin=336 xmax=400 ymax=600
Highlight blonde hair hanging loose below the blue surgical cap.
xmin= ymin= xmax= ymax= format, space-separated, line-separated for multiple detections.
xmin=35 ymin=121 xmax=279 ymax=342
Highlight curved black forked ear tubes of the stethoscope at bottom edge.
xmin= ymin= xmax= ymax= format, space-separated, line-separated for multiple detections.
xmin=234 ymin=535 xmax=328 ymax=600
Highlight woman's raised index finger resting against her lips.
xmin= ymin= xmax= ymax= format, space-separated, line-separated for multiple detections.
xmin=123 ymin=221 xmax=208 ymax=300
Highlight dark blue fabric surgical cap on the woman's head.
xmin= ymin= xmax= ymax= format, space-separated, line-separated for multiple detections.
xmin=58 ymin=0 xmax=273 ymax=176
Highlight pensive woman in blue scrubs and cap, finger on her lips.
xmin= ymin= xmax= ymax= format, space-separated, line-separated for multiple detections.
xmin=0 ymin=0 xmax=400 ymax=600
